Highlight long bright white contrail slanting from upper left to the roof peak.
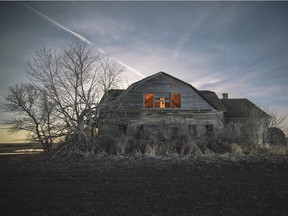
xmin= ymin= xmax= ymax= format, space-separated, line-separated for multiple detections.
xmin=23 ymin=3 xmax=146 ymax=78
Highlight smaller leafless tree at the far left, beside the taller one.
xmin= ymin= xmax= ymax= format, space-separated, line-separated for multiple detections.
xmin=4 ymin=84 xmax=63 ymax=152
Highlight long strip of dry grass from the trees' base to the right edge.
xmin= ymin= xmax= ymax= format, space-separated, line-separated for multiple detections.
xmin=49 ymin=133 xmax=288 ymax=158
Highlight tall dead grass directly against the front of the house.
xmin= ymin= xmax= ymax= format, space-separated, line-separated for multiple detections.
xmin=89 ymin=136 xmax=244 ymax=156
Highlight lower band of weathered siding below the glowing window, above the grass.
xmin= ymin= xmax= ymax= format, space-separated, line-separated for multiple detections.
xmin=101 ymin=110 xmax=224 ymax=136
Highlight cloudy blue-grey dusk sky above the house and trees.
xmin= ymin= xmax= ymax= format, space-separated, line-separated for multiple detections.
xmin=0 ymin=1 xmax=288 ymax=142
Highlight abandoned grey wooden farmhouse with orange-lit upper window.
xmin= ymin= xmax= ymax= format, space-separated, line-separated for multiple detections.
xmin=99 ymin=72 xmax=269 ymax=142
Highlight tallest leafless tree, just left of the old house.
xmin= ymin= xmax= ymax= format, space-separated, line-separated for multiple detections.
xmin=28 ymin=39 xmax=123 ymax=148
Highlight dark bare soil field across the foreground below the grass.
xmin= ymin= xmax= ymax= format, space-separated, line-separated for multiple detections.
xmin=0 ymin=155 xmax=288 ymax=216
